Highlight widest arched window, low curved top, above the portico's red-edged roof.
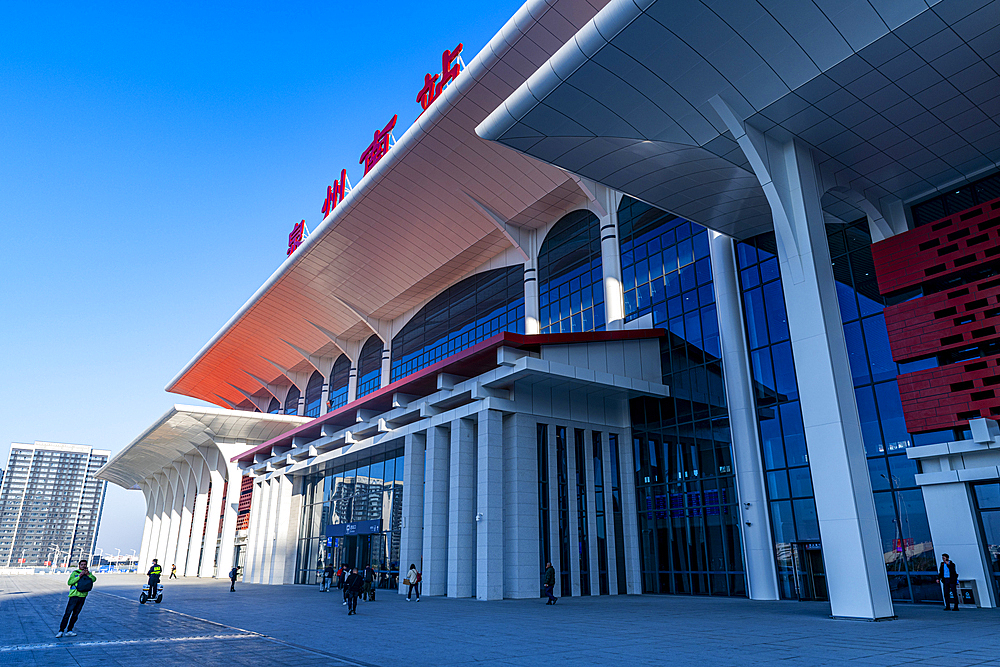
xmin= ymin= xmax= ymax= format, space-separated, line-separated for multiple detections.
xmin=390 ymin=264 xmax=524 ymax=382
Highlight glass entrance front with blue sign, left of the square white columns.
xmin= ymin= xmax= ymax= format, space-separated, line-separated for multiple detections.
xmin=295 ymin=448 xmax=403 ymax=586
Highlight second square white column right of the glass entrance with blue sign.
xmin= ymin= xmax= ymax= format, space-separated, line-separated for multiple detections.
xmin=421 ymin=426 xmax=450 ymax=595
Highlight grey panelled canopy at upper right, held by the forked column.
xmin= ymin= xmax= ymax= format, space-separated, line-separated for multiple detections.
xmin=478 ymin=0 xmax=1000 ymax=238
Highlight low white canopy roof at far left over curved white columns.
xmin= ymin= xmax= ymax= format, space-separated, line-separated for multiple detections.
xmin=95 ymin=405 xmax=311 ymax=489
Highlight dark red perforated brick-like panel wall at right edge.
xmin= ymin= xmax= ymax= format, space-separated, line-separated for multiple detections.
xmin=872 ymin=199 xmax=1000 ymax=433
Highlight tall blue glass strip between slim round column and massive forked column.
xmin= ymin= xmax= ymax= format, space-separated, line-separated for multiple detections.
xmin=736 ymin=233 xmax=827 ymax=600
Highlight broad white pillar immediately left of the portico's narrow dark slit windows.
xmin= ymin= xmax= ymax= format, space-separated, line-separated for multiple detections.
xmin=503 ymin=413 xmax=543 ymax=599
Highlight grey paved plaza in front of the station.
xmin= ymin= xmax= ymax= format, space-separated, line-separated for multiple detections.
xmin=0 ymin=575 xmax=1000 ymax=667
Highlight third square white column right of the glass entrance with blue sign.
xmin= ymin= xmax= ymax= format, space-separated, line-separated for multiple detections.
xmin=448 ymin=419 xmax=476 ymax=598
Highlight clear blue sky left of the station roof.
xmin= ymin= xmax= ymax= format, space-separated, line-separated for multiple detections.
xmin=0 ymin=0 xmax=521 ymax=553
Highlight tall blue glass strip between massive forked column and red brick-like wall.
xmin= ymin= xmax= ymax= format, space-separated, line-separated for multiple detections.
xmin=827 ymin=219 xmax=941 ymax=602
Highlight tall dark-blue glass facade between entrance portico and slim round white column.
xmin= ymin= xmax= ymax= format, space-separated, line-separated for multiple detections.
xmin=613 ymin=197 xmax=746 ymax=595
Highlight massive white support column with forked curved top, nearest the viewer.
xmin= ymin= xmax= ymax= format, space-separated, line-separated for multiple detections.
xmin=711 ymin=97 xmax=894 ymax=620
